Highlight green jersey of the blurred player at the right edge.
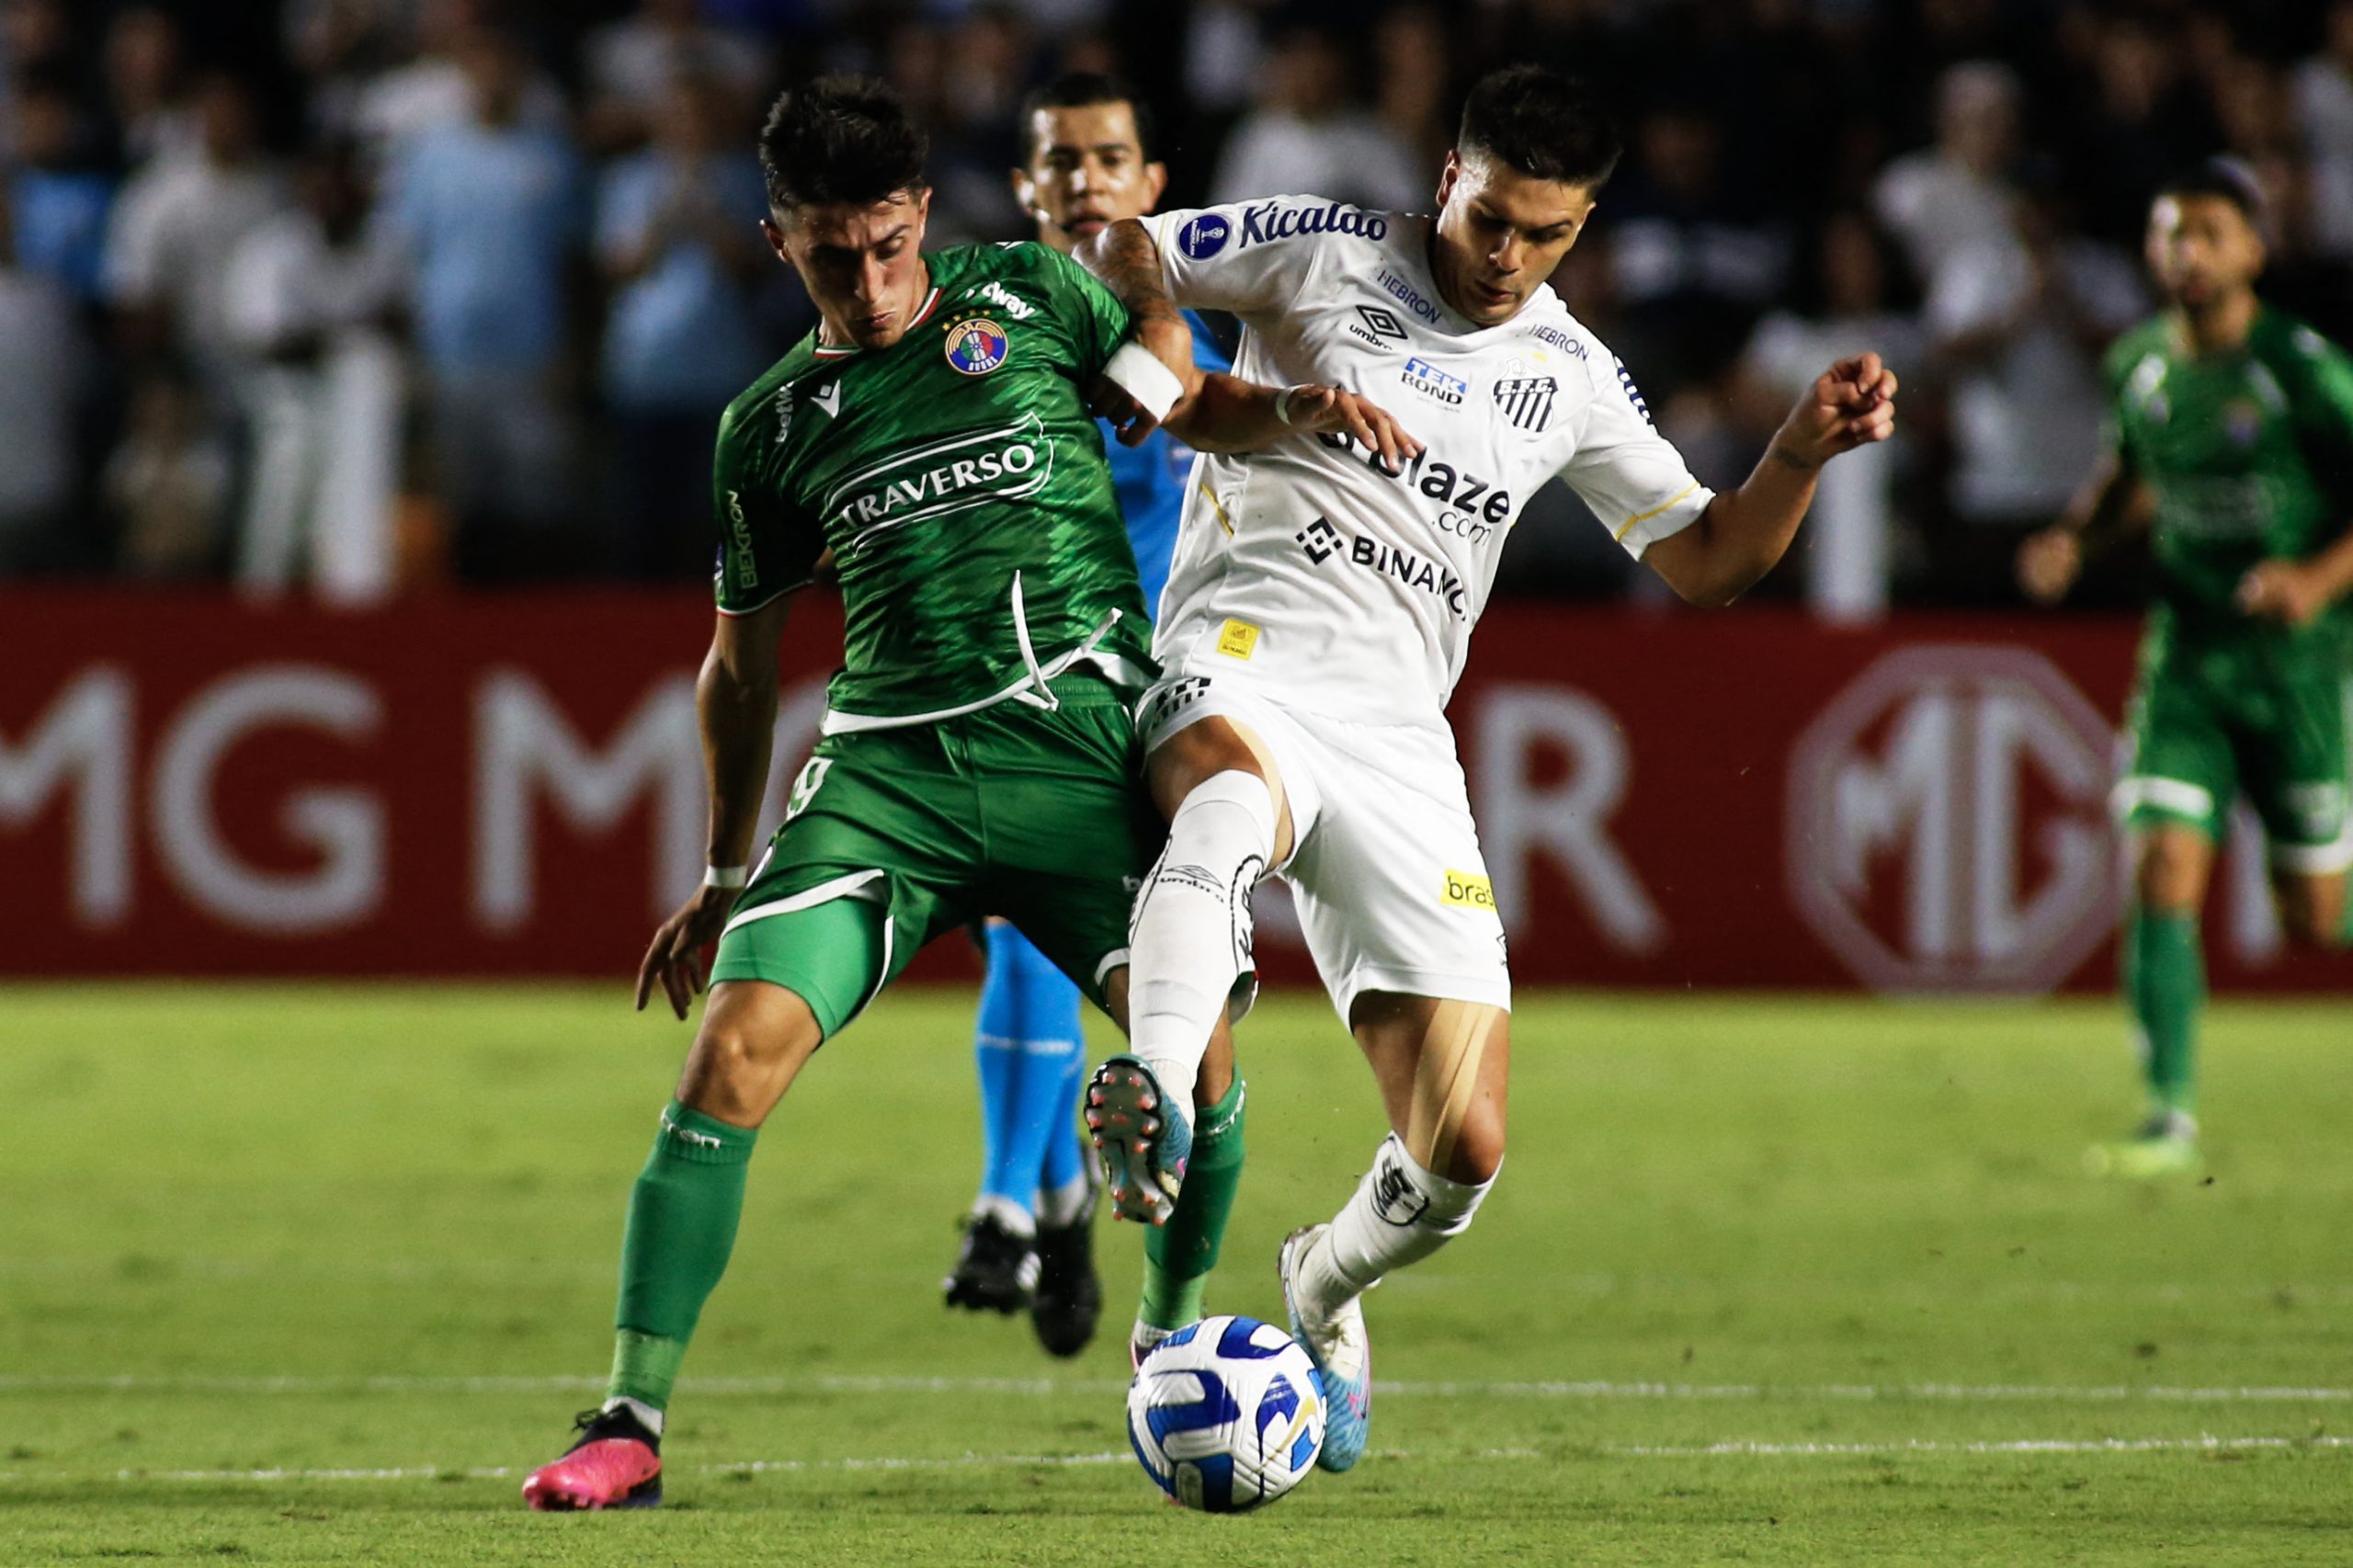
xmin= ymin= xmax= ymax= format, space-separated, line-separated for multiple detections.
xmin=2106 ymin=306 xmax=2353 ymax=638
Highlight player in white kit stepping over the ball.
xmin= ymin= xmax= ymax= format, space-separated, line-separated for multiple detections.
xmin=1083 ymin=66 xmax=1896 ymax=1469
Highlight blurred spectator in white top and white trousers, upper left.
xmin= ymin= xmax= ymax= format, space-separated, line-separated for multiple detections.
xmin=223 ymin=146 xmax=407 ymax=605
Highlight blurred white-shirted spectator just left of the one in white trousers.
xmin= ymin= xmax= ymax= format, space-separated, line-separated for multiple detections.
xmin=104 ymin=73 xmax=282 ymax=391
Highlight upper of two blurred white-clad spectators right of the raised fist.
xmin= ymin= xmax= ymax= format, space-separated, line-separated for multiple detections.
xmin=1873 ymin=62 xmax=2018 ymax=288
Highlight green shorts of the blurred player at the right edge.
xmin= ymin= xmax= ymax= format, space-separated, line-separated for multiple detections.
xmin=2115 ymin=629 xmax=2353 ymax=876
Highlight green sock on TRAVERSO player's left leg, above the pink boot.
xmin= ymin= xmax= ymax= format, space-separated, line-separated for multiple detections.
xmin=607 ymin=1099 xmax=760 ymax=1410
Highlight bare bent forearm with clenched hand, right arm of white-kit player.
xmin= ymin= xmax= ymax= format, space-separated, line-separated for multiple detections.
xmin=1643 ymin=353 xmax=1896 ymax=605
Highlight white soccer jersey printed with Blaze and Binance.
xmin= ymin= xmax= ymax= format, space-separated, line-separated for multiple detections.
xmin=1146 ymin=196 xmax=1713 ymax=722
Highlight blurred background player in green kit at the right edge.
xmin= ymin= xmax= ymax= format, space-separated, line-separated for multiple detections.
xmin=2018 ymin=163 xmax=2353 ymax=1177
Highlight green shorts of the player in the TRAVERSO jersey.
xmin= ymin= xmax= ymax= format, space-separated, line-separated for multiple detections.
xmin=710 ymin=674 xmax=1167 ymax=1039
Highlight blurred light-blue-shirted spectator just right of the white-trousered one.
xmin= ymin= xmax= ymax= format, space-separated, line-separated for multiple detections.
xmin=386 ymin=28 xmax=584 ymax=579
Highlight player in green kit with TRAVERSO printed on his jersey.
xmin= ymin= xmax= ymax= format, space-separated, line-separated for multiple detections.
xmin=522 ymin=78 xmax=1398 ymax=1509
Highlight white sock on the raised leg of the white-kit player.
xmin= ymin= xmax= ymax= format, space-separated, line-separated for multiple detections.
xmin=1127 ymin=767 xmax=1276 ymax=1096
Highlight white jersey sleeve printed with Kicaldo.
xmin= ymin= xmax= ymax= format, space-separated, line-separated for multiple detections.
xmin=1143 ymin=196 xmax=1355 ymax=315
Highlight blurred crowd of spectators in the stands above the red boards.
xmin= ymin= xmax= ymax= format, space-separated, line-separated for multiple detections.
xmin=0 ymin=0 xmax=2353 ymax=619
